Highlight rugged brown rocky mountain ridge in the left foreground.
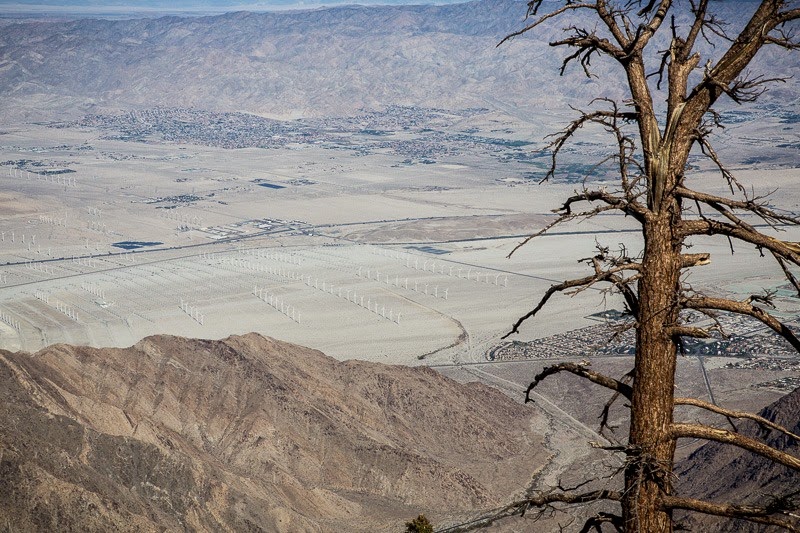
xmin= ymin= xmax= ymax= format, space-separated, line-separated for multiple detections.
xmin=0 ymin=334 xmax=548 ymax=531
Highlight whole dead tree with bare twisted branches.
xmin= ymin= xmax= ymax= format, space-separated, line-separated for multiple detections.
xmin=488 ymin=0 xmax=800 ymax=533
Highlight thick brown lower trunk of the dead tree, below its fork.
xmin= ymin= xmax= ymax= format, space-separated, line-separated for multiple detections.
xmin=622 ymin=210 xmax=681 ymax=533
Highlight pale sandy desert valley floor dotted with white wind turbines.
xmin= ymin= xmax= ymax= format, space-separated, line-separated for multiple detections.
xmin=0 ymin=112 xmax=800 ymax=380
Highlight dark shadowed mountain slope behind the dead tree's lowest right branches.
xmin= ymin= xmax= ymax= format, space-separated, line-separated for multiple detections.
xmin=676 ymin=389 xmax=800 ymax=533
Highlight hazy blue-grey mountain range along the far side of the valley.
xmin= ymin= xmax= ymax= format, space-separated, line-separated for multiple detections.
xmin=0 ymin=0 xmax=788 ymax=121
